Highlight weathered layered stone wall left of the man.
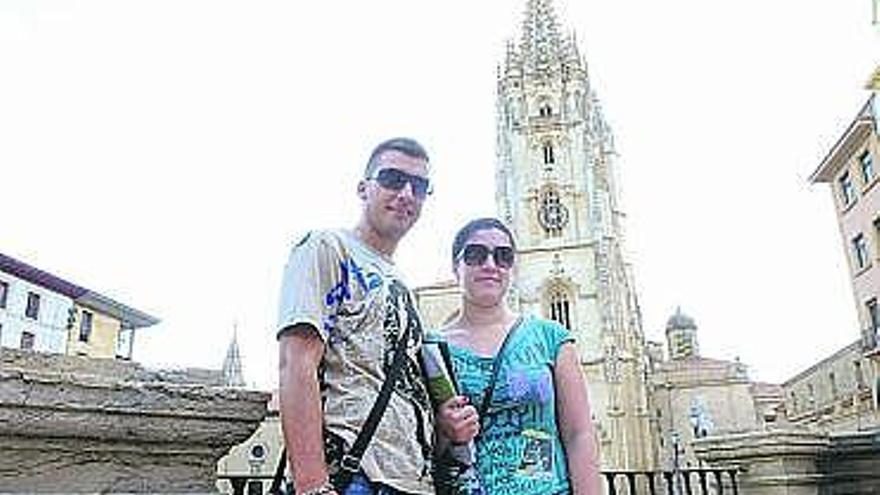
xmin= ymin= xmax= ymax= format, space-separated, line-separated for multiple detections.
xmin=0 ymin=349 xmax=269 ymax=493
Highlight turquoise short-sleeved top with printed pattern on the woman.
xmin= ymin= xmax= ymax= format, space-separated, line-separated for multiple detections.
xmin=449 ymin=316 xmax=574 ymax=495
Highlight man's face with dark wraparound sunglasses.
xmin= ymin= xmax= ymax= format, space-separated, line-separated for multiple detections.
xmin=361 ymin=150 xmax=428 ymax=242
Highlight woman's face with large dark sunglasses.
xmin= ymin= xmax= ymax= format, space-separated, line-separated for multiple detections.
xmin=455 ymin=229 xmax=514 ymax=306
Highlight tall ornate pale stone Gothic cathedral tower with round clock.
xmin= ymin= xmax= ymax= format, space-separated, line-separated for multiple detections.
xmin=496 ymin=0 xmax=655 ymax=469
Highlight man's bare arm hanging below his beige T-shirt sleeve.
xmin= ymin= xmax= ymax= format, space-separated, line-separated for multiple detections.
xmin=278 ymin=325 xmax=328 ymax=493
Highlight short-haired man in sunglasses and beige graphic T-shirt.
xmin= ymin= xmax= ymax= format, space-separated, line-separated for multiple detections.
xmin=278 ymin=138 xmax=477 ymax=495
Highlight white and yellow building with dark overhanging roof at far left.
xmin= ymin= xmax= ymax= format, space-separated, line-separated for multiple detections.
xmin=0 ymin=254 xmax=159 ymax=359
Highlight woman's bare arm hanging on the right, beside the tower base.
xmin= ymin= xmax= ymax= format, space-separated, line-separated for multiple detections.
xmin=553 ymin=343 xmax=602 ymax=495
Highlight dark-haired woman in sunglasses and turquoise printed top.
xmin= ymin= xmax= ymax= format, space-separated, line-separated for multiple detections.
xmin=438 ymin=218 xmax=601 ymax=495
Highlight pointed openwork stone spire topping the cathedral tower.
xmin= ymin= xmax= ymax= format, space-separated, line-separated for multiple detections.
xmin=520 ymin=0 xmax=563 ymax=73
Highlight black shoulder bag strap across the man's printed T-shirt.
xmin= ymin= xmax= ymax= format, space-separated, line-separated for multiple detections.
xmin=269 ymin=325 xmax=410 ymax=494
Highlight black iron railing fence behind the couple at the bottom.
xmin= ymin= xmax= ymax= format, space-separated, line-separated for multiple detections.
xmin=218 ymin=468 xmax=739 ymax=495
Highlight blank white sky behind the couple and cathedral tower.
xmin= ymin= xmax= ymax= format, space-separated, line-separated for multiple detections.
xmin=0 ymin=0 xmax=880 ymax=387
